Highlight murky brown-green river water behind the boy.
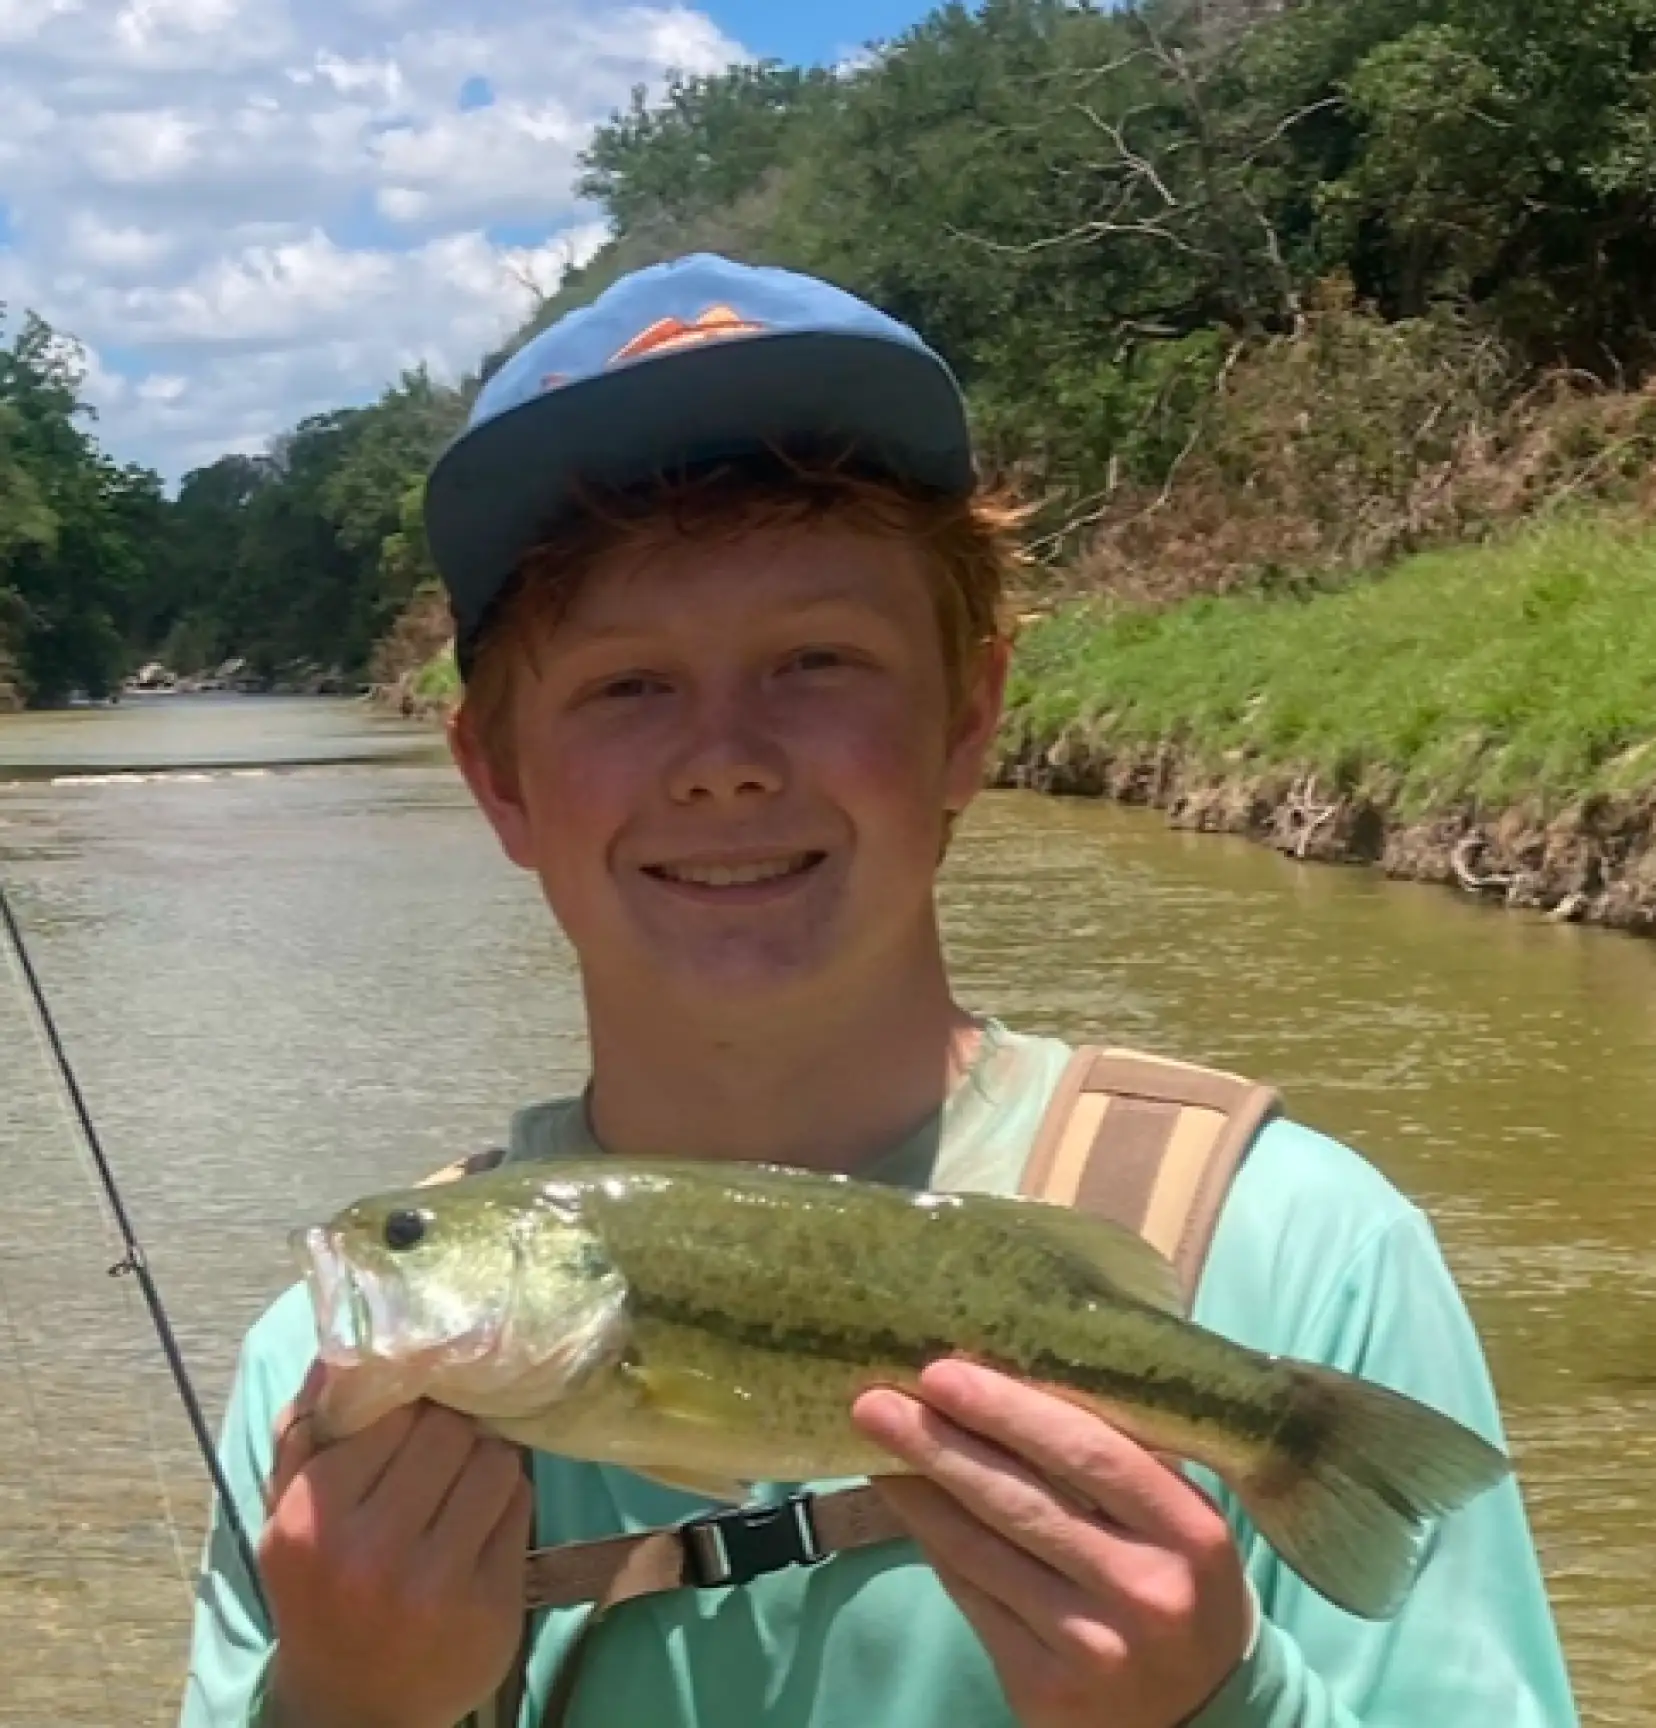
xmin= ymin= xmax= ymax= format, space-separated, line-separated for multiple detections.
xmin=0 ymin=698 xmax=1656 ymax=1728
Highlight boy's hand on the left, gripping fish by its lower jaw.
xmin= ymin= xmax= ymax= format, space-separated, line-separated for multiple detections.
xmin=259 ymin=1370 xmax=531 ymax=1728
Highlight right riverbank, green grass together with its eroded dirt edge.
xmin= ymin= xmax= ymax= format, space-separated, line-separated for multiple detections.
xmin=996 ymin=518 xmax=1656 ymax=935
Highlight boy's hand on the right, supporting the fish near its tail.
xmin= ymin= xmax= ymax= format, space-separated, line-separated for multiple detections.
xmin=854 ymin=1362 xmax=1253 ymax=1728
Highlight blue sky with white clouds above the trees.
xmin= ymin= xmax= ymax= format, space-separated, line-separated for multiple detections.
xmin=0 ymin=0 xmax=930 ymax=487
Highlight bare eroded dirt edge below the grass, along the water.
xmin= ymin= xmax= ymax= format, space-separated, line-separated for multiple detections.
xmin=994 ymin=729 xmax=1656 ymax=937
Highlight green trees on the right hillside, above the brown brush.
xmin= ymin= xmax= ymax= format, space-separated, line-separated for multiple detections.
xmin=534 ymin=0 xmax=1656 ymax=520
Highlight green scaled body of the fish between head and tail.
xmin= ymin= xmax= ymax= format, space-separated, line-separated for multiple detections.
xmin=577 ymin=1180 xmax=1309 ymax=1455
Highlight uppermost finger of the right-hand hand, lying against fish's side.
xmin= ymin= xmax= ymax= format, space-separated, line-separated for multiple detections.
xmin=920 ymin=1362 xmax=1213 ymax=1545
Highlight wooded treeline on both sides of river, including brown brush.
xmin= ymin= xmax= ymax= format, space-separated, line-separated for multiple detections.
xmin=12 ymin=0 xmax=1656 ymax=700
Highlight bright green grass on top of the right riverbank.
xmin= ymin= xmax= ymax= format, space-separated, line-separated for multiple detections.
xmin=1010 ymin=520 xmax=1656 ymax=816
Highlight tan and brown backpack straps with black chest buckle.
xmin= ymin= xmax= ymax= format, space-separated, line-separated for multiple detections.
xmin=442 ymin=1045 xmax=1281 ymax=1728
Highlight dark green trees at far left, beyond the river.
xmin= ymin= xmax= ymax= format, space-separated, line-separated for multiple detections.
xmin=0 ymin=297 xmax=465 ymax=705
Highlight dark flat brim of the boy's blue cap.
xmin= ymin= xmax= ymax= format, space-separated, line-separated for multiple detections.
xmin=425 ymin=332 xmax=973 ymax=634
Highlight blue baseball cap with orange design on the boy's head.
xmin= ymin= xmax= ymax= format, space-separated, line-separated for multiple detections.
xmin=424 ymin=252 xmax=975 ymax=669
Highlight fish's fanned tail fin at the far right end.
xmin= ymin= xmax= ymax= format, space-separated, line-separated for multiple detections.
xmin=1234 ymin=1362 xmax=1511 ymax=1619
